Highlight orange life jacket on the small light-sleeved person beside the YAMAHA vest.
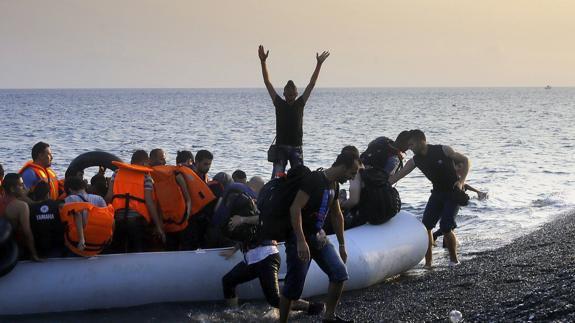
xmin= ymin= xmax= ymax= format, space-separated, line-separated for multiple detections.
xmin=60 ymin=202 xmax=114 ymax=257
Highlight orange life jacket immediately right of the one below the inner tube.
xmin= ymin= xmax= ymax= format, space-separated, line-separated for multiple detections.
xmin=152 ymin=166 xmax=188 ymax=232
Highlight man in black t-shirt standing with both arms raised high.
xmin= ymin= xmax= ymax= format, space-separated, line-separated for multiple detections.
xmin=258 ymin=45 xmax=329 ymax=178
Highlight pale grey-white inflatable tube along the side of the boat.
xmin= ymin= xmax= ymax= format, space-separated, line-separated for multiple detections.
xmin=0 ymin=211 xmax=427 ymax=315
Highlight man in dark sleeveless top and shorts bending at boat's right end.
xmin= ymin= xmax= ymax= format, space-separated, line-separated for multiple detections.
xmin=390 ymin=130 xmax=469 ymax=269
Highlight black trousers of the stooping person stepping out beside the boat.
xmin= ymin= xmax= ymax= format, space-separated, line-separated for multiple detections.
xmin=222 ymin=253 xmax=280 ymax=308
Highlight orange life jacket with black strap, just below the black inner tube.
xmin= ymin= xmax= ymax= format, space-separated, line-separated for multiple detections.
xmin=112 ymin=161 xmax=152 ymax=223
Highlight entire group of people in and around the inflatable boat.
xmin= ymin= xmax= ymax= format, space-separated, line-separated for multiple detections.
xmin=0 ymin=46 xmax=486 ymax=322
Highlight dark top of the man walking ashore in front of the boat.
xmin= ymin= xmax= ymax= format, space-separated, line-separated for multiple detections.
xmin=300 ymin=170 xmax=339 ymax=235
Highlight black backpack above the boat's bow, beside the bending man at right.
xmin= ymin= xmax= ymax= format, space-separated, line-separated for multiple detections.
xmin=358 ymin=168 xmax=401 ymax=224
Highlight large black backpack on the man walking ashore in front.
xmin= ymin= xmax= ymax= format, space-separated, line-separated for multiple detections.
xmin=257 ymin=165 xmax=311 ymax=241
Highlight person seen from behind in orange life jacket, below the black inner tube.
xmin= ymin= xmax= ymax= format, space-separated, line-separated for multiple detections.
xmin=106 ymin=150 xmax=166 ymax=253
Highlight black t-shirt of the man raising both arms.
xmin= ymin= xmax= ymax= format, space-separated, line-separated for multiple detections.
xmin=274 ymin=95 xmax=305 ymax=146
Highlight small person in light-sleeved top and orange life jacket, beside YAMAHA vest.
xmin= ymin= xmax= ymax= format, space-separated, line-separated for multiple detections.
xmin=60 ymin=176 xmax=114 ymax=257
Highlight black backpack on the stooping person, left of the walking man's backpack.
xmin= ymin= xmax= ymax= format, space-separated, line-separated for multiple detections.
xmin=214 ymin=190 xmax=259 ymax=243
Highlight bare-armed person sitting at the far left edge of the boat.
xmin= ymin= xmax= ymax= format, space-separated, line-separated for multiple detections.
xmin=0 ymin=173 xmax=40 ymax=261
